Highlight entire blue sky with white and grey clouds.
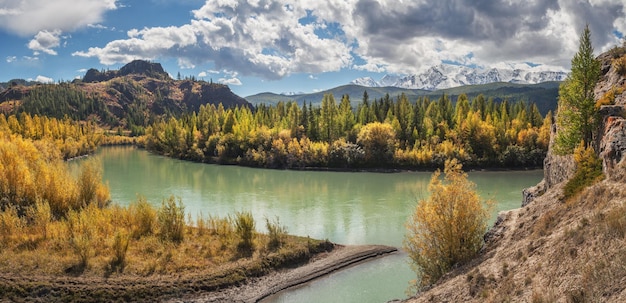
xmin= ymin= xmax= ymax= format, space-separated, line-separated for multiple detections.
xmin=0 ymin=0 xmax=626 ymax=97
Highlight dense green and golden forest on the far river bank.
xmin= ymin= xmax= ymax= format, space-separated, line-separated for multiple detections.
xmin=146 ymin=92 xmax=552 ymax=169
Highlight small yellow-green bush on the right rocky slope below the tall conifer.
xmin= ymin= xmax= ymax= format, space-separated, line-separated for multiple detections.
xmin=563 ymin=141 xmax=604 ymax=198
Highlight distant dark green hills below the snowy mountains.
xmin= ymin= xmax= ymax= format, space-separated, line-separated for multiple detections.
xmin=245 ymin=82 xmax=560 ymax=115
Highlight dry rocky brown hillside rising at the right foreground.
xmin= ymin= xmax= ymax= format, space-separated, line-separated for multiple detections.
xmin=408 ymin=50 xmax=626 ymax=302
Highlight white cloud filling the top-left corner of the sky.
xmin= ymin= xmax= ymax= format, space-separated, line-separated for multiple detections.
xmin=0 ymin=0 xmax=117 ymax=36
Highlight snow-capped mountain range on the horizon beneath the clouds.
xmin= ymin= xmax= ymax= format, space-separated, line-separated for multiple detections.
xmin=350 ymin=64 xmax=567 ymax=90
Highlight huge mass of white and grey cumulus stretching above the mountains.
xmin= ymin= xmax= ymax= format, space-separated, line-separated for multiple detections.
xmin=72 ymin=0 xmax=626 ymax=80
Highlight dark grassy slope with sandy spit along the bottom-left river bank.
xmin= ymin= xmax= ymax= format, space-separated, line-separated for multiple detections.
xmin=0 ymin=245 xmax=397 ymax=302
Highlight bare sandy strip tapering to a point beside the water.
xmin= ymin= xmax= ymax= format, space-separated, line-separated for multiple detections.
xmin=180 ymin=245 xmax=397 ymax=303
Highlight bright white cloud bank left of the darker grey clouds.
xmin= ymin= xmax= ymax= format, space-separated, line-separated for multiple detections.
xmin=74 ymin=1 xmax=352 ymax=79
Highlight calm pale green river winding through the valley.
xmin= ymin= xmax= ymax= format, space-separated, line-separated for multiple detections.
xmin=72 ymin=147 xmax=543 ymax=303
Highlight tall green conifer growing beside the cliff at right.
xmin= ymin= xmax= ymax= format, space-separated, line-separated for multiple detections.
xmin=555 ymin=25 xmax=600 ymax=154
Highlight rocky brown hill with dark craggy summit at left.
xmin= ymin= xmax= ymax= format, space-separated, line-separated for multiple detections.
xmin=0 ymin=60 xmax=250 ymax=127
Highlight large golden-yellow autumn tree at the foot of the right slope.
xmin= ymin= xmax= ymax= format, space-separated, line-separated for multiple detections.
xmin=404 ymin=159 xmax=493 ymax=288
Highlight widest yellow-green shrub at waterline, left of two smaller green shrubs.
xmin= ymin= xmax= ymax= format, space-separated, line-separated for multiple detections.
xmin=157 ymin=196 xmax=185 ymax=243
